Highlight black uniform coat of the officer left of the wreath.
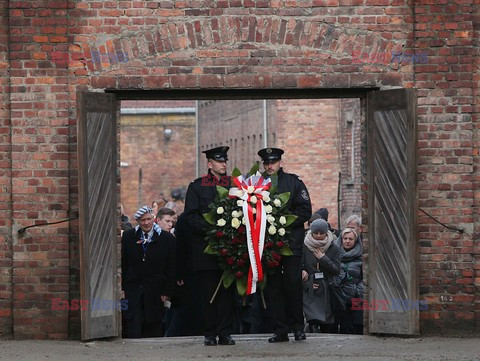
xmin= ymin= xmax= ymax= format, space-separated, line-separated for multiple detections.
xmin=184 ymin=171 xmax=230 ymax=271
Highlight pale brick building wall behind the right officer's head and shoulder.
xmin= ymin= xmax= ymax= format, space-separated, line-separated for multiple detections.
xmin=272 ymin=99 xmax=340 ymax=227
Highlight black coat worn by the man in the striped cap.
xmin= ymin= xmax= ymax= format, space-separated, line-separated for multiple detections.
xmin=122 ymin=228 xmax=175 ymax=323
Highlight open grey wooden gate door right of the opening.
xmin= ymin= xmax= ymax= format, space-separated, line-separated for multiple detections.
xmin=367 ymin=89 xmax=419 ymax=335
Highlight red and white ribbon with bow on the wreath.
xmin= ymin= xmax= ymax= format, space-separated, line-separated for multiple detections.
xmin=228 ymin=172 xmax=271 ymax=295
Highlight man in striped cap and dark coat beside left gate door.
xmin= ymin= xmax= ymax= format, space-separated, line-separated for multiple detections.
xmin=122 ymin=205 xmax=175 ymax=338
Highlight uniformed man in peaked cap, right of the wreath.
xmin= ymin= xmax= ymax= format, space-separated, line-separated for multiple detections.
xmin=258 ymin=148 xmax=312 ymax=342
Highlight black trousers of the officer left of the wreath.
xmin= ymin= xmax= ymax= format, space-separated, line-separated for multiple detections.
xmin=198 ymin=270 xmax=235 ymax=336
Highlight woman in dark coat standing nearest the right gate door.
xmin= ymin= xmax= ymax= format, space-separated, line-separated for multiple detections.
xmin=338 ymin=228 xmax=363 ymax=335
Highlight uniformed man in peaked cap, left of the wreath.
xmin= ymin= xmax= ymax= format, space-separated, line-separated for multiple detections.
xmin=179 ymin=146 xmax=235 ymax=346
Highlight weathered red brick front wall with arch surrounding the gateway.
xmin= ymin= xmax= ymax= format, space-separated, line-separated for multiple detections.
xmin=0 ymin=0 xmax=480 ymax=338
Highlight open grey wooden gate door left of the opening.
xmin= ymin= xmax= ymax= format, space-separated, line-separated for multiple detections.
xmin=77 ymin=93 xmax=119 ymax=340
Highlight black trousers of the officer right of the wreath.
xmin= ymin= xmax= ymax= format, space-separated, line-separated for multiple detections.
xmin=265 ymin=256 xmax=304 ymax=334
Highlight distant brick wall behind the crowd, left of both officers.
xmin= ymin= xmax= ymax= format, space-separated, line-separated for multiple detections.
xmin=120 ymin=108 xmax=195 ymax=218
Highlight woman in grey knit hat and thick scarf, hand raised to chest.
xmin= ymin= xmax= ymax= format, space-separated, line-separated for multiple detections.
xmin=302 ymin=219 xmax=341 ymax=333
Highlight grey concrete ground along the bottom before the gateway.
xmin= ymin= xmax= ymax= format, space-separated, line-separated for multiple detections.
xmin=0 ymin=334 xmax=480 ymax=361
